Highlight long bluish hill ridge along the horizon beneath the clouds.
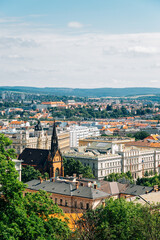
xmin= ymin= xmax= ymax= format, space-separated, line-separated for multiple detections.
xmin=0 ymin=86 xmax=160 ymax=97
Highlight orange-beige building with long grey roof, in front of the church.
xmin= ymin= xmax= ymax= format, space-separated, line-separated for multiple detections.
xmin=25 ymin=177 xmax=110 ymax=213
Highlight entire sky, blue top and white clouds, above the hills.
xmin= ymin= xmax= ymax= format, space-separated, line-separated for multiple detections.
xmin=0 ymin=0 xmax=160 ymax=88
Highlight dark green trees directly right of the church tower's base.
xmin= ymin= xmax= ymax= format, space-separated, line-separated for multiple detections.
xmin=63 ymin=158 xmax=94 ymax=178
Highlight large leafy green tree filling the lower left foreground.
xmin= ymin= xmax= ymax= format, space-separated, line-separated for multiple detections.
xmin=0 ymin=134 xmax=70 ymax=240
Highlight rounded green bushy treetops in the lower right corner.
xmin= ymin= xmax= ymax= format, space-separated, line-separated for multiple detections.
xmin=74 ymin=198 xmax=160 ymax=240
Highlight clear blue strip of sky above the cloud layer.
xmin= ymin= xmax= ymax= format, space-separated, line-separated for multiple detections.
xmin=0 ymin=0 xmax=160 ymax=33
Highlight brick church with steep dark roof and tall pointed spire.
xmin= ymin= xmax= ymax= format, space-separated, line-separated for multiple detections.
xmin=19 ymin=122 xmax=64 ymax=178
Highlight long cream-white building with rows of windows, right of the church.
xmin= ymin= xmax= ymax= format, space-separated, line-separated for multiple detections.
xmin=64 ymin=144 xmax=160 ymax=179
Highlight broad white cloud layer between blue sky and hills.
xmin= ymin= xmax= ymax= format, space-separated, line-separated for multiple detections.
xmin=0 ymin=18 xmax=160 ymax=88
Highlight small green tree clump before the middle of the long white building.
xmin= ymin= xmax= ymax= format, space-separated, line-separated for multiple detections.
xmin=104 ymin=171 xmax=133 ymax=183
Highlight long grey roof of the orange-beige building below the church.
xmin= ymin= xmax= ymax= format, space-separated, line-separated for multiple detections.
xmin=26 ymin=180 xmax=110 ymax=199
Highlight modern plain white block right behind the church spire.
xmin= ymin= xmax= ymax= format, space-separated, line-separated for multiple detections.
xmin=69 ymin=125 xmax=100 ymax=147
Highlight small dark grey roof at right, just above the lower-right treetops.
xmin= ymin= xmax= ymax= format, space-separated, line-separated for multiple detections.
xmin=121 ymin=184 xmax=153 ymax=196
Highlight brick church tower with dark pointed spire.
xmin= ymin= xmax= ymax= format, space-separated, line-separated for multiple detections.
xmin=49 ymin=121 xmax=64 ymax=178
